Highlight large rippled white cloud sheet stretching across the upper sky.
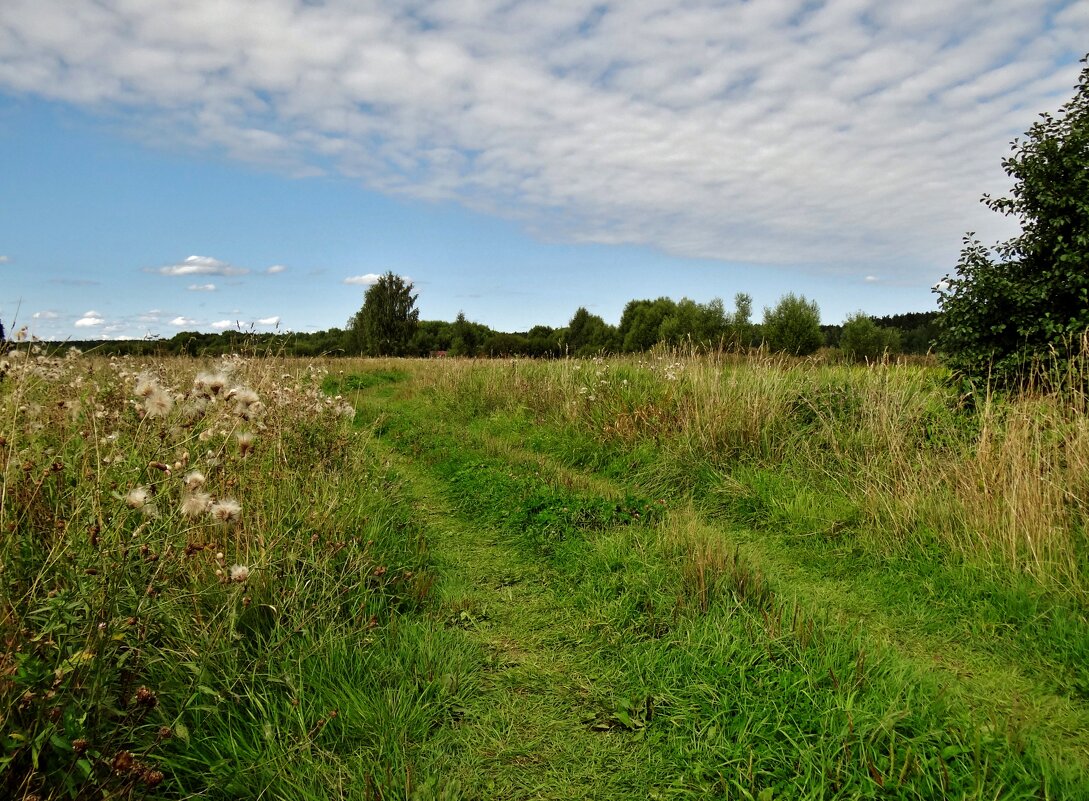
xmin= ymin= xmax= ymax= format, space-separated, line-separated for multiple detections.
xmin=0 ymin=0 xmax=1089 ymax=284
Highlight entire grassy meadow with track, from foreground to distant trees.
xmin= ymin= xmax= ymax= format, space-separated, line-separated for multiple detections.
xmin=0 ymin=349 xmax=1089 ymax=801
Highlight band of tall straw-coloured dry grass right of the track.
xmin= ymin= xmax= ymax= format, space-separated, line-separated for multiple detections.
xmin=405 ymin=352 xmax=1089 ymax=597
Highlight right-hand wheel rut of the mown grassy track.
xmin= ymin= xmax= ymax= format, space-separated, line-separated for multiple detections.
xmin=473 ymin=415 xmax=1089 ymax=775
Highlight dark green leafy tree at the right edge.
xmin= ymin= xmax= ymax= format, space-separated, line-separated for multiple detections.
xmin=938 ymin=57 xmax=1089 ymax=386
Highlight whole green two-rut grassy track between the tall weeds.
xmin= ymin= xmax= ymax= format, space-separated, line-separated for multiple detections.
xmin=344 ymin=370 xmax=1086 ymax=799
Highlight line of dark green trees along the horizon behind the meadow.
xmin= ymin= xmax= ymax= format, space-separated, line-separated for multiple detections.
xmin=29 ymin=287 xmax=938 ymax=360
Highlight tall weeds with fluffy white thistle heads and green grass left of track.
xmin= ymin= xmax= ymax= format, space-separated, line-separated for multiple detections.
xmin=0 ymin=349 xmax=470 ymax=799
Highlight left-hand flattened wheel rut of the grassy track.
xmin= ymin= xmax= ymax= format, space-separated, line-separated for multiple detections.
xmin=374 ymin=444 xmax=646 ymax=799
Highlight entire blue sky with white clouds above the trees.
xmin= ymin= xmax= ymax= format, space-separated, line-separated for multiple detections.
xmin=0 ymin=0 xmax=1089 ymax=340
